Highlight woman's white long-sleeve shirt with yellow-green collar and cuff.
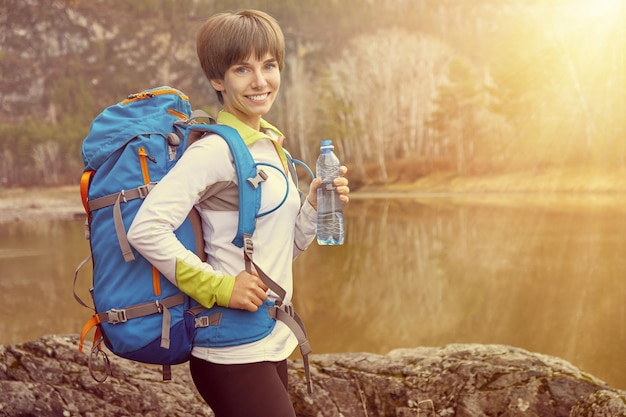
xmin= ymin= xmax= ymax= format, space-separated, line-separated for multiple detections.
xmin=128 ymin=112 xmax=316 ymax=363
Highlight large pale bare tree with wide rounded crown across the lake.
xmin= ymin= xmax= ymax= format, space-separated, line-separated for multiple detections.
xmin=321 ymin=29 xmax=453 ymax=181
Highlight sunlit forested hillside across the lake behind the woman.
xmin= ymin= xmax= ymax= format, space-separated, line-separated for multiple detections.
xmin=0 ymin=0 xmax=626 ymax=188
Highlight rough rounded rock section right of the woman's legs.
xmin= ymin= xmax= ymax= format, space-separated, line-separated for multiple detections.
xmin=290 ymin=345 xmax=626 ymax=417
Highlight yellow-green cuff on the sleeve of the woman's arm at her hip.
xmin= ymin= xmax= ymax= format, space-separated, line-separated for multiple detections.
xmin=176 ymin=259 xmax=235 ymax=308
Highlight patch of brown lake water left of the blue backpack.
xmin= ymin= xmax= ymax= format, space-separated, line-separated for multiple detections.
xmin=0 ymin=221 xmax=89 ymax=344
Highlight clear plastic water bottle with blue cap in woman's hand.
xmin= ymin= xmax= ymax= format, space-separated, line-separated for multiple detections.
xmin=315 ymin=140 xmax=344 ymax=245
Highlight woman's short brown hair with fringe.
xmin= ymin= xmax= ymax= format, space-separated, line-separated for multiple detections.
xmin=196 ymin=10 xmax=285 ymax=102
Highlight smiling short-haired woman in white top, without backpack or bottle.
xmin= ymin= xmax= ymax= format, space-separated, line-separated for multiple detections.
xmin=128 ymin=10 xmax=350 ymax=417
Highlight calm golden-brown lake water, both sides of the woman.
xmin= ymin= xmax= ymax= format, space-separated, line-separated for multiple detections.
xmin=0 ymin=194 xmax=626 ymax=389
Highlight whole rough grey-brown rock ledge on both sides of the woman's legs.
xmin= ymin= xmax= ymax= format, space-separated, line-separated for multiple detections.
xmin=0 ymin=335 xmax=626 ymax=417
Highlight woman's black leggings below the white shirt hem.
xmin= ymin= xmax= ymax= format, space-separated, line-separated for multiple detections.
xmin=189 ymin=356 xmax=296 ymax=417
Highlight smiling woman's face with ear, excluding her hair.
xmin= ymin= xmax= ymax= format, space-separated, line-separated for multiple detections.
xmin=211 ymin=53 xmax=280 ymax=130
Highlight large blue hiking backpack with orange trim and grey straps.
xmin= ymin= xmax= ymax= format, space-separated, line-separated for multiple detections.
xmin=74 ymin=86 xmax=264 ymax=381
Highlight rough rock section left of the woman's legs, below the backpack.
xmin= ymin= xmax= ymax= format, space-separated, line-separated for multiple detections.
xmin=0 ymin=336 xmax=213 ymax=417
